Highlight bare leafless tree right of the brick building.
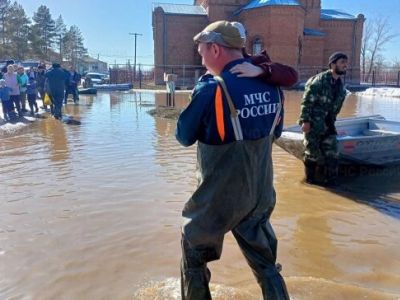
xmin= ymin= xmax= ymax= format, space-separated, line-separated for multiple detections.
xmin=361 ymin=17 xmax=397 ymax=81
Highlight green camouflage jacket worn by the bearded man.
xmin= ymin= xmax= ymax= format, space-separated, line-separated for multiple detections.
xmin=299 ymin=70 xmax=346 ymax=133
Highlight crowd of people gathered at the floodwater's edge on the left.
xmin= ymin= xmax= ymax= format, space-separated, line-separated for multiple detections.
xmin=0 ymin=60 xmax=81 ymax=121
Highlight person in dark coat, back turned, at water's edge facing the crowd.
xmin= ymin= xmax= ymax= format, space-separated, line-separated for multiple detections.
xmin=45 ymin=63 xmax=69 ymax=120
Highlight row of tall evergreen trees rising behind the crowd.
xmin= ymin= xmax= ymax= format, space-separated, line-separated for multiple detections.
xmin=0 ymin=0 xmax=87 ymax=64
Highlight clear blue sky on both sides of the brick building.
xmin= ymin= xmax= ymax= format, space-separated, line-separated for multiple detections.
xmin=22 ymin=0 xmax=400 ymax=64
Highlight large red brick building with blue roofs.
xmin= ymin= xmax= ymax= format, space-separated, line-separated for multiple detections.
xmin=153 ymin=0 xmax=364 ymax=83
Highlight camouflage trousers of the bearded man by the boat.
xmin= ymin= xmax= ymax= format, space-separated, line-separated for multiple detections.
xmin=303 ymin=130 xmax=339 ymax=165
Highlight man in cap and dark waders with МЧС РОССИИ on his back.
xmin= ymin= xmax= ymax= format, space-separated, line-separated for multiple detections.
xmin=176 ymin=21 xmax=289 ymax=300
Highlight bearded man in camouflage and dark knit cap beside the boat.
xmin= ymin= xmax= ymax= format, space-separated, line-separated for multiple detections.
xmin=299 ymin=52 xmax=347 ymax=185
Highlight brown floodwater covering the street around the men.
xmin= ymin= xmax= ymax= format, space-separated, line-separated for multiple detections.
xmin=0 ymin=92 xmax=400 ymax=300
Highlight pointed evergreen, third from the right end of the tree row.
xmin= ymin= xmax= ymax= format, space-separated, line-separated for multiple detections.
xmin=33 ymin=5 xmax=55 ymax=58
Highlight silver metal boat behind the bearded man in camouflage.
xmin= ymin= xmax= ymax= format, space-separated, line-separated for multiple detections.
xmin=276 ymin=115 xmax=400 ymax=166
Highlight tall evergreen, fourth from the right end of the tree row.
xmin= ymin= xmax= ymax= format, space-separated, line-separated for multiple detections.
xmin=6 ymin=2 xmax=30 ymax=60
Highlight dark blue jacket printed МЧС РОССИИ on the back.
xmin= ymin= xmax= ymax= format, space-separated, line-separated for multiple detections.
xmin=176 ymin=59 xmax=281 ymax=146
